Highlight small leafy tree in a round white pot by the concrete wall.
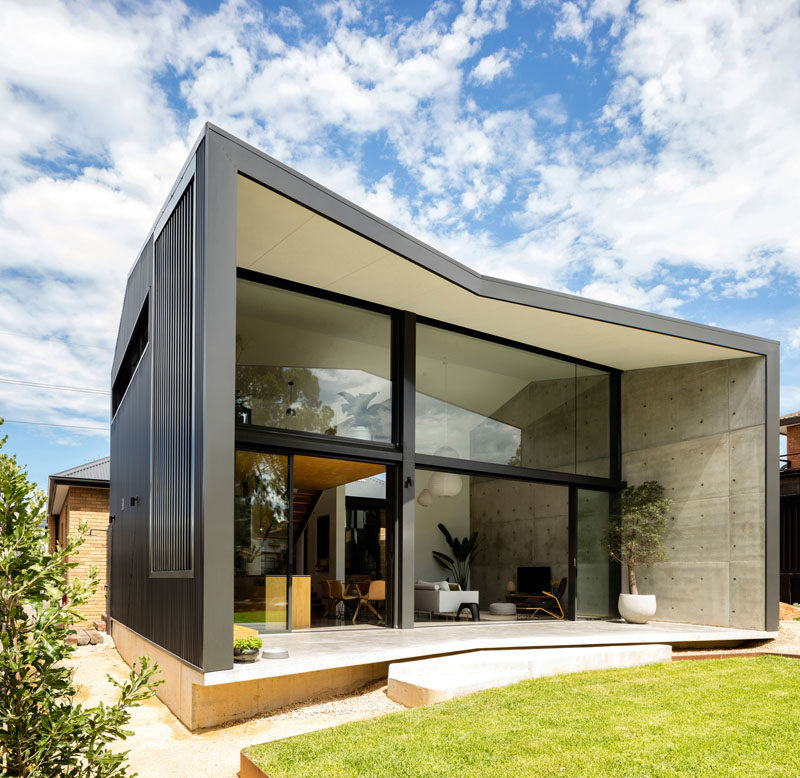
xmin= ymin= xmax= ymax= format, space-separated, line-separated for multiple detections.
xmin=606 ymin=481 xmax=672 ymax=624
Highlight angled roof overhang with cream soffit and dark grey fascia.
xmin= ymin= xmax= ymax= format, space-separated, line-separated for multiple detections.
xmin=225 ymin=127 xmax=777 ymax=370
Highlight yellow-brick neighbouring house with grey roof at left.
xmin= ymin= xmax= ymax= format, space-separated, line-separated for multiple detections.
xmin=47 ymin=457 xmax=110 ymax=624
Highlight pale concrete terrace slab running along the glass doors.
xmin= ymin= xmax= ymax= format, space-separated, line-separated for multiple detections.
xmin=201 ymin=621 xmax=777 ymax=686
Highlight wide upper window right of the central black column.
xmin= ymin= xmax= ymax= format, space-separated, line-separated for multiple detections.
xmin=416 ymin=324 xmax=610 ymax=477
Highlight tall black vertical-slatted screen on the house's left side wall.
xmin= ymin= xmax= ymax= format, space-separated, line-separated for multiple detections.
xmin=150 ymin=181 xmax=194 ymax=574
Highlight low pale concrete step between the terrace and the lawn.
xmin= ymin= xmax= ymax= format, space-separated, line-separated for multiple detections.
xmin=387 ymin=644 xmax=672 ymax=708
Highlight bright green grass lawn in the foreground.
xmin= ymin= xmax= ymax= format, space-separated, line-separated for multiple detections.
xmin=247 ymin=657 xmax=800 ymax=778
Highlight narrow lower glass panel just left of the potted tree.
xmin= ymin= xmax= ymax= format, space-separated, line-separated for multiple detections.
xmin=575 ymin=489 xmax=616 ymax=619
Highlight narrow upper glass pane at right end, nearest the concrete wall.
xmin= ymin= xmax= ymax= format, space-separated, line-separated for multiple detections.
xmin=575 ymin=365 xmax=611 ymax=478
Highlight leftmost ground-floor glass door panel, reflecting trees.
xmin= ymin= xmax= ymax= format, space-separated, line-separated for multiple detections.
xmin=233 ymin=451 xmax=289 ymax=632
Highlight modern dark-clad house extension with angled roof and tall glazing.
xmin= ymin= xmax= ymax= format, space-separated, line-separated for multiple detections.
xmin=110 ymin=125 xmax=779 ymax=727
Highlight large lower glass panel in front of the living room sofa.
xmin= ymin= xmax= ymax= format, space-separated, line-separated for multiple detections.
xmin=414 ymin=470 xmax=569 ymax=618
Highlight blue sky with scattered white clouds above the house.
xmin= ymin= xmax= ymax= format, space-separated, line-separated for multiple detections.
xmin=0 ymin=0 xmax=800 ymax=487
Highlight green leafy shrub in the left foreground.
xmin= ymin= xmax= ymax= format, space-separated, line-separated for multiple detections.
xmin=0 ymin=419 xmax=158 ymax=778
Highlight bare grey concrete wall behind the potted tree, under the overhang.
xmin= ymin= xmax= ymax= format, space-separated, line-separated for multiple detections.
xmin=622 ymin=357 xmax=766 ymax=629
